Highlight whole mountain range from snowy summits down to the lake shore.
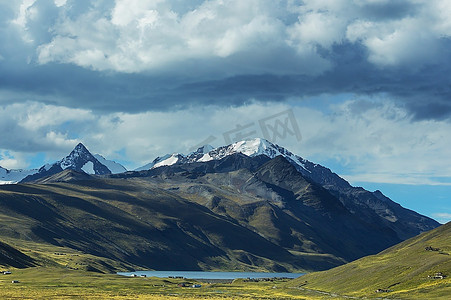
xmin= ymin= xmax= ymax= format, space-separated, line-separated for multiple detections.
xmin=0 ymin=139 xmax=439 ymax=271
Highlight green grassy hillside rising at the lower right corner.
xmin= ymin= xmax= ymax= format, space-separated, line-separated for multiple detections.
xmin=288 ymin=222 xmax=451 ymax=299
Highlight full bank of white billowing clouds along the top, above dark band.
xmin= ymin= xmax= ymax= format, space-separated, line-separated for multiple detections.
xmin=9 ymin=0 xmax=451 ymax=74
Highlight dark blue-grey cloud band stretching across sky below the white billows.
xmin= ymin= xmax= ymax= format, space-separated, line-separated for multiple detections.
xmin=0 ymin=44 xmax=451 ymax=119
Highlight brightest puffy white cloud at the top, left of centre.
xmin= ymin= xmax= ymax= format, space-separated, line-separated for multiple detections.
xmin=37 ymin=0 xmax=314 ymax=72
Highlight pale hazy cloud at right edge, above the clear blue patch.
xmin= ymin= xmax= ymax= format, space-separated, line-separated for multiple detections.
xmin=292 ymin=99 xmax=451 ymax=185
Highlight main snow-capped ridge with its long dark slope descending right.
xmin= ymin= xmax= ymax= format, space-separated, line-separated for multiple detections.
xmin=138 ymin=138 xmax=440 ymax=240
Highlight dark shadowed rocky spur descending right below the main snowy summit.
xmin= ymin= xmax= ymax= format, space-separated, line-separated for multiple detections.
xmin=255 ymin=156 xmax=400 ymax=261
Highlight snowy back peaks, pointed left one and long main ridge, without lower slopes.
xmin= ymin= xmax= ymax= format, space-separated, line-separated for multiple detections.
xmin=10 ymin=138 xmax=437 ymax=240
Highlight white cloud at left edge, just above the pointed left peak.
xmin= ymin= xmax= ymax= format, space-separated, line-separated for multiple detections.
xmin=0 ymin=102 xmax=96 ymax=161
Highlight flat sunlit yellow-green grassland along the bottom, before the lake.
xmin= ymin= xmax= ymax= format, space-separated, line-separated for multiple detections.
xmin=0 ymin=267 xmax=321 ymax=300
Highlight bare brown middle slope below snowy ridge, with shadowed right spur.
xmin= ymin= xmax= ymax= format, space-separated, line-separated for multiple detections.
xmin=111 ymin=153 xmax=414 ymax=270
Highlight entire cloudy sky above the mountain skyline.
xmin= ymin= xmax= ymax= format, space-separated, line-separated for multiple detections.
xmin=0 ymin=0 xmax=451 ymax=222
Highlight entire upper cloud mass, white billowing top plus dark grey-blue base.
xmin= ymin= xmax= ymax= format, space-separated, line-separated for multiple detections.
xmin=0 ymin=0 xmax=451 ymax=119
